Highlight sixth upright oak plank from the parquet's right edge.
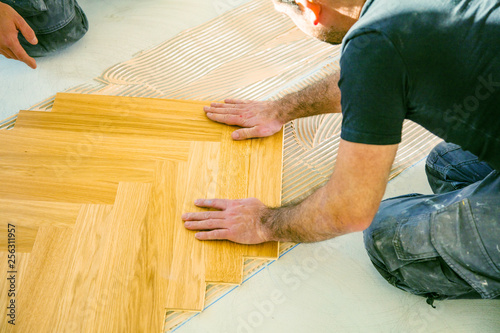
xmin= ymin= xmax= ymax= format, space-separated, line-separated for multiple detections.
xmin=47 ymin=205 xmax=113 ymax=332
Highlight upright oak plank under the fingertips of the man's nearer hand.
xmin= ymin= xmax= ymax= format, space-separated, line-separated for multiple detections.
xmin=167 ymin=142 xmax=220 ymax=311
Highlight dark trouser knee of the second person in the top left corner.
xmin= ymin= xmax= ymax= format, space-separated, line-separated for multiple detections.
xmin=0 ymin=0 xmax=88 ymax=57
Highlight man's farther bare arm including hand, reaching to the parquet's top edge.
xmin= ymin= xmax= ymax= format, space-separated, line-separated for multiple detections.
xmin=205 ymin=72 xmax=341 ymax=140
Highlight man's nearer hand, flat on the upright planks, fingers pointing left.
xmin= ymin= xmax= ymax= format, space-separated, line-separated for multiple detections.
xmin=182 ymin=198 xmax=272 ymax=244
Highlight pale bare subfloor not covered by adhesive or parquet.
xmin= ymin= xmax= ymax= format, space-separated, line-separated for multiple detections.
xmin=0 ymin=0 xmax=500 ymax=332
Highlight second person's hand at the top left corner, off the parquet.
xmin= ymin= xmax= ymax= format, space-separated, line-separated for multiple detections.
xmin=0 ymin=2 xmax=38 ymax=69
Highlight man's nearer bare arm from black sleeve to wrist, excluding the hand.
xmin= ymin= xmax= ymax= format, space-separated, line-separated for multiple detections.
xmin=262 ymin=141 xmax=397 ymax=242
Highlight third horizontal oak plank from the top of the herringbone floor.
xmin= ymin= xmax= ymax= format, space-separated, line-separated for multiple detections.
xmin=0 ymin=128 xmax=190 ymax=161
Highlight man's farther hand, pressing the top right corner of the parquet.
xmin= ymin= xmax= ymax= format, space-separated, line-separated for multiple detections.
xmin=205 ymin=99 xmax=286 ymax=140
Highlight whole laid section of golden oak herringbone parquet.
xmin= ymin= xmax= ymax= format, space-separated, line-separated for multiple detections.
xmin=0 ymin=94 xmax=282 ymax=332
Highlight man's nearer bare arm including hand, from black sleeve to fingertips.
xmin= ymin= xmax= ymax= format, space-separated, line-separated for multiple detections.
xmin=183 ymin=141 xmax=397 ymax=244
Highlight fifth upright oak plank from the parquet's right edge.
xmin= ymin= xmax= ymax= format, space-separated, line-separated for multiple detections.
xmin=90 ymin=183 xmax=154 ymax=332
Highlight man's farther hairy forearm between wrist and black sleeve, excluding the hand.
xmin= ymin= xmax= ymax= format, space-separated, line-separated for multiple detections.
xmin=275 ymin=72 xmax=341 ymax=123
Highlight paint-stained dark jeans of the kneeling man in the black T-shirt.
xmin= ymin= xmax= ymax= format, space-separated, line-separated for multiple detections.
xmin=364 ymin=143 xmax=500 ymax=304
